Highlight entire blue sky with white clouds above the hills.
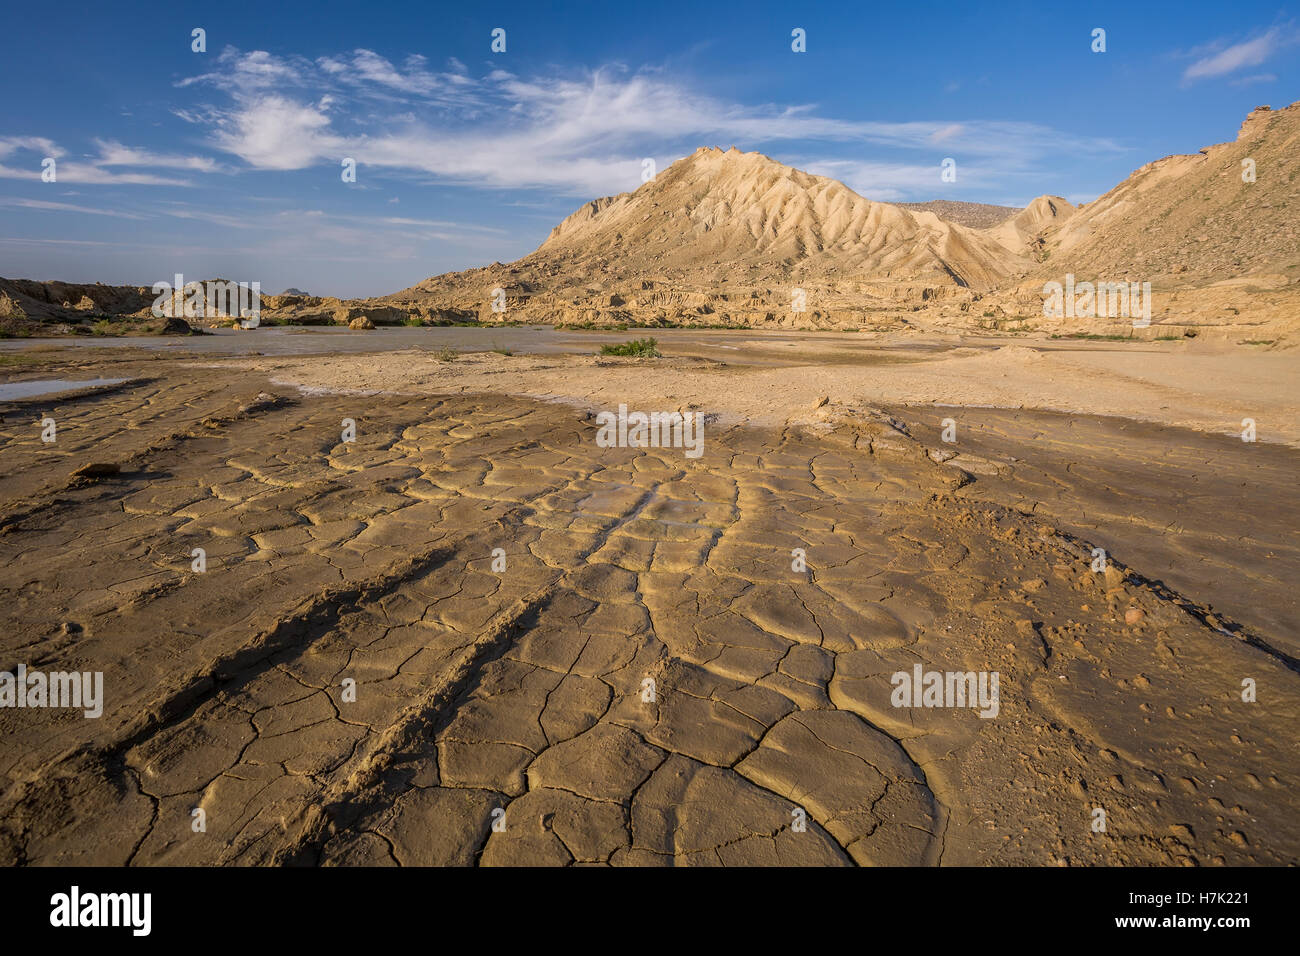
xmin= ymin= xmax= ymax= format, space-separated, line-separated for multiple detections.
xmin=0 ymin=0 xmax=1300 ymax=297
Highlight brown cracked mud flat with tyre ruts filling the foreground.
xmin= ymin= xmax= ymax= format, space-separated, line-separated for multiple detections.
xmin=0 ymin=359 xmax=1300 ymax=865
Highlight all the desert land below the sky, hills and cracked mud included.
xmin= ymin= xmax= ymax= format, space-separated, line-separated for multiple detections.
xmin=0 ymin=103 xmax=1300 ymax=865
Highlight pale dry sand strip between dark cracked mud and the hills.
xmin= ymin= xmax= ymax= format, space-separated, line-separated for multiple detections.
xmin=231 ymin=333 xmax=1300 ymax=446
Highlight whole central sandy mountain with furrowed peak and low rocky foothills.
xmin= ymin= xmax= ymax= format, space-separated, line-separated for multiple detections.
xmin=380 ymin=147 xmax=1066 ymax=328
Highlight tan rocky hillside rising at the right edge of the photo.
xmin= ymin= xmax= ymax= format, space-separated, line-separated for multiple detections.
xmin=987 ymin=103 xmax=1300 ymax=342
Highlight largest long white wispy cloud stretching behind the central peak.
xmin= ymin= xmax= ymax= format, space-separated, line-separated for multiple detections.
xmin=183 ymin=49 xmax=1119 ymax=196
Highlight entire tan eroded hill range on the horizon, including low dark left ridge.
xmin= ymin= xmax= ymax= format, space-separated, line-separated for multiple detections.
xmin=0 ymin=103 xmax=1300 ymax=341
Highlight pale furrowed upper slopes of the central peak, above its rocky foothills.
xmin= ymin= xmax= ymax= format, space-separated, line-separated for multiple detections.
xmin=534 ymin=147 xmax=1015 ymax=286
